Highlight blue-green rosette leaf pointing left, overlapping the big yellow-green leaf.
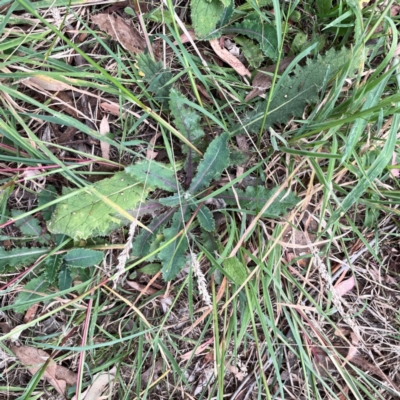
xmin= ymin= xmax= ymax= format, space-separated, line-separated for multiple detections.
xmin=125 ymin=159 xmax=178 ymax=192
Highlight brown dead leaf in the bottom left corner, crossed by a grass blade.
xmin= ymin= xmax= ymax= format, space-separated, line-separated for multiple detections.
xmin=11 ymin=346 xmax=76 ymax=395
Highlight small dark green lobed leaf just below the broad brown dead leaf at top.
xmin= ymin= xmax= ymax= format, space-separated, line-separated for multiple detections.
xmin=136 ymin=53 xmax=173 ymax=102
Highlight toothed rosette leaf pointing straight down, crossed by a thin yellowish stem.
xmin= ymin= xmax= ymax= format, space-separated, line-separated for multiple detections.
xmin=159 ymin=210 xmax=188 ymax=281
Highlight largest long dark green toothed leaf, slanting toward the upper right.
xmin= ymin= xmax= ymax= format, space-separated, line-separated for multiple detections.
xmin=235 ymin=48 xmax=350 ymax=133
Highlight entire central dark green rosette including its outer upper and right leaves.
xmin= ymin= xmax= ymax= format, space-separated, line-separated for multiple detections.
xmin=126 ymin=90 xmax=298 ymax=281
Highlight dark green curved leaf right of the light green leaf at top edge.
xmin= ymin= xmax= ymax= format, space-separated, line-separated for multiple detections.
xmin=224 ymin=19 xmax=278 ymax=60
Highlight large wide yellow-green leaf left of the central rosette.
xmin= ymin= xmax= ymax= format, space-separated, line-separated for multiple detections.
xmin=47 ymin=172 xmax=150 ymax=239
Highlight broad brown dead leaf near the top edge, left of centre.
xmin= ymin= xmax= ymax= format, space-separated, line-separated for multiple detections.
xmin=92 ymin=13 xmax=146 ymax=54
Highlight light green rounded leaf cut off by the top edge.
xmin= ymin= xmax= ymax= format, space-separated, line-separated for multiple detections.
xmin=190 ymin=0 xmax=225 ymax=39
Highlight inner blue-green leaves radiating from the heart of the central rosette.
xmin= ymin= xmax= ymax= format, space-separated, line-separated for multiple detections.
xmin=126 ymin=133 xmax=230 ymax=281
